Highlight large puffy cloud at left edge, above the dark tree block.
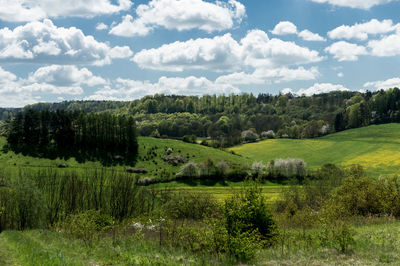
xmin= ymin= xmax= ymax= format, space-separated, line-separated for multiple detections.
xmin=0 ymin=19 xmax=132 ymax=65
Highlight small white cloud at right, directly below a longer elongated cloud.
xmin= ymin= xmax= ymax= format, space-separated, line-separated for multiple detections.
xmin=325 ymin=41 xmax=368 ymax=62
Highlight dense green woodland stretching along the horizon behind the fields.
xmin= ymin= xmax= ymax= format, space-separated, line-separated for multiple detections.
xmin=3 ymin=88 xmax=400 ymax=147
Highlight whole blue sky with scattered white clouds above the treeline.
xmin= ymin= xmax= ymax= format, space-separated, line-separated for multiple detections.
xmin=0 ymin=0 xmax=400 ymax=107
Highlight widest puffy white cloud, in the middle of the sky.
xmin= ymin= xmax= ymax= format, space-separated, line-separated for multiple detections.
xmin=133 ymin=30 xmax=322 ymax=72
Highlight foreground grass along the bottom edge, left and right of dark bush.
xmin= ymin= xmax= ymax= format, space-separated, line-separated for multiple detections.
xmin=0 ymin=222 xmax=400 ymax=265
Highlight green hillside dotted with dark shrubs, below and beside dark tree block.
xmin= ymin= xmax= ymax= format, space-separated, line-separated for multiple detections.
xmin=0 ymin=137 xmax=250 ymax=178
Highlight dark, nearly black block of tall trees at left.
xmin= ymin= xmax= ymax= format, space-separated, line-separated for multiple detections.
xmin=7 ymin=109 xmax=138 ymax=165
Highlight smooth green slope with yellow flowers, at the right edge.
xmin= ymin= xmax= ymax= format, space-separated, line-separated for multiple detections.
xmin=230 ymin=124 xmax=400 ymax=176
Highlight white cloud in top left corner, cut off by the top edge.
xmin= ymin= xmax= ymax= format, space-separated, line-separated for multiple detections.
xmin=0 ymin=0 xmax=132 ymax=22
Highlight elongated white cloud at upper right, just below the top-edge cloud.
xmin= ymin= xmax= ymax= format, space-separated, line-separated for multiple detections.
xmin=328 ymin=19 xmax=396 ymax=41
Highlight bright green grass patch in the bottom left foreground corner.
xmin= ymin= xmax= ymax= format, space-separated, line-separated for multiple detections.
xmin=0 ymin=230 xmax=225 ymax=266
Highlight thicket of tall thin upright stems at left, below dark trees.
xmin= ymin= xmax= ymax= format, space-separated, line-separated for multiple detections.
xmin=0 ymin=169 xmax=155 ymax=231
